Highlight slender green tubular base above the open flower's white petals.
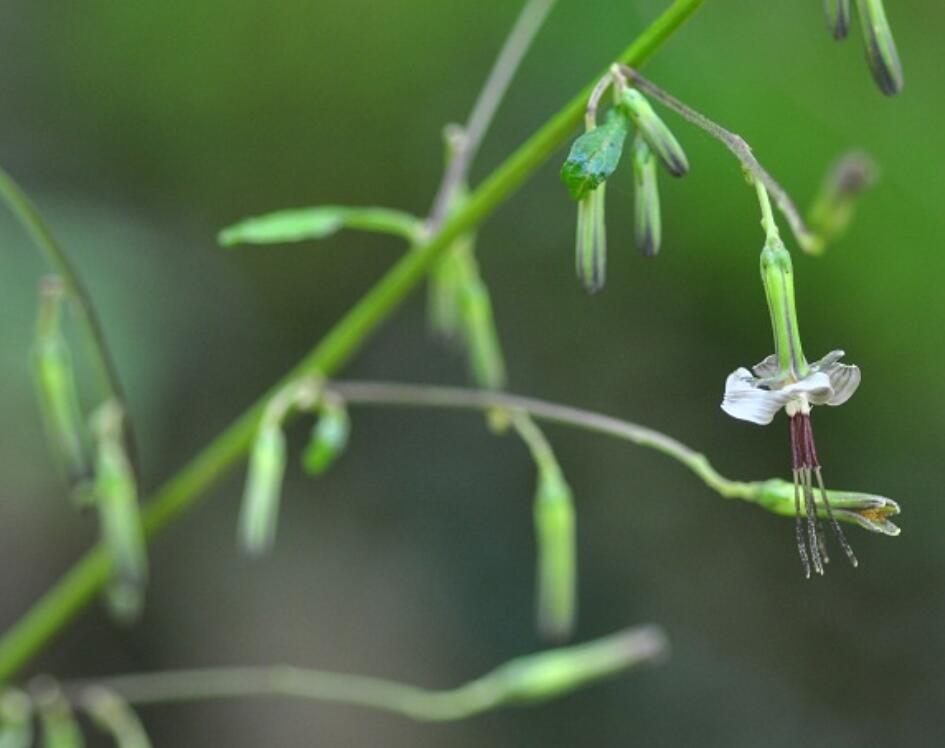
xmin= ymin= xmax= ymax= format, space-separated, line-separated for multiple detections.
xmin=761 ymin=235 xmax=810 ymax=379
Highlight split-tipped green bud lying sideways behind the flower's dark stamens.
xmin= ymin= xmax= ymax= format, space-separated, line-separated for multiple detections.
xmin=749 ymin=478 xmax=900 ymax=537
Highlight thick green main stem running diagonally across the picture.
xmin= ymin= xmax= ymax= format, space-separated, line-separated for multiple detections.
xmin=0 ymin=0 xmax=705 ymax=682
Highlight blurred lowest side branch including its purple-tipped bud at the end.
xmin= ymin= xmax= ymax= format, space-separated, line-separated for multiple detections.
xmin=62 ymin=626 xmax=668 ymax=722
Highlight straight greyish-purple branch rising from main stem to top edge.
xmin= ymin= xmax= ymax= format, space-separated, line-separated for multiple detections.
xmin=427 ymin=0 xmax=557 ymax=231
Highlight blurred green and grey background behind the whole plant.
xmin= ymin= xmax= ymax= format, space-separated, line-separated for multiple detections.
xmin=0 ymin=0 xmax=945 ymax=748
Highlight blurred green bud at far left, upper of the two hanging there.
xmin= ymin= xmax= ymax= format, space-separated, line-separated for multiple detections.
xmin=33 ymin=276 xmax=92 ymax=496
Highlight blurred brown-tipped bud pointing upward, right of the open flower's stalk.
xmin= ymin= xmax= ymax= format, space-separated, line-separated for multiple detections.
xmin=807 ymin=153 xmax=876 ymax=250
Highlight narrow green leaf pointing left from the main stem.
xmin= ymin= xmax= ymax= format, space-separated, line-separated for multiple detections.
xmin=217 ymin=205 xmax=422 ymax=247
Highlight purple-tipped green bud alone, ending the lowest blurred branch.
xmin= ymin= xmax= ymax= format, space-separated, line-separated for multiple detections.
xmin=483 ymin=626 xmax=668 ymax=704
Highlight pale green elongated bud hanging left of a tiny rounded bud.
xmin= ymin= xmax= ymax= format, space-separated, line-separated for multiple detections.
xmin=238 ymin=420 xmax=286 ymax=556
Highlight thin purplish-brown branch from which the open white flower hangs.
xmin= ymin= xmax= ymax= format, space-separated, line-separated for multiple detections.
xmin=620 ymin=65 xmax=819 ymax=252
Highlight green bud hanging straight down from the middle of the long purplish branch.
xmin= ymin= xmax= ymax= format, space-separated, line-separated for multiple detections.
xmin=534 ymin=460 xmax=577 ymax=641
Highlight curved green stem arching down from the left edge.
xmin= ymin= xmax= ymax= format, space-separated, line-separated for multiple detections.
xmin=0 ymin=167 xmax=138 ymax=469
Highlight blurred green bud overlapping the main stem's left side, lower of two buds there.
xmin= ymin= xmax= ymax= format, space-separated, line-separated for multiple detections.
xmin=92 ymin=401 xmax=148 ymax=621
